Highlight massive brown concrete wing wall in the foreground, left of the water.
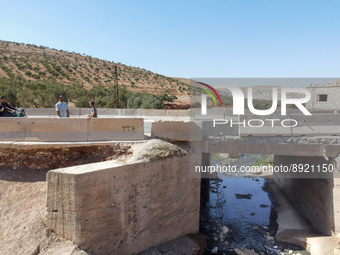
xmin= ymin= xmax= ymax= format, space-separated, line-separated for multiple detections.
xmin=46 ymin=156 xmax=200 ymax=255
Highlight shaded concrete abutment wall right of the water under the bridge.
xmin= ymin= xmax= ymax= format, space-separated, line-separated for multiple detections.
xmin=274 ymin=155 xmax=340 ymax=235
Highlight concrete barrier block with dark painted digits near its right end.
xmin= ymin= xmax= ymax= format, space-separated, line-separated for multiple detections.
xmin=88 ymin=118 xmax=144 ymax=141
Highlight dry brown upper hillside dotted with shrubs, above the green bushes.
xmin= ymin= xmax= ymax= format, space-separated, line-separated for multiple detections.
xmin=0 ymin=40 xmax=190 ymax=108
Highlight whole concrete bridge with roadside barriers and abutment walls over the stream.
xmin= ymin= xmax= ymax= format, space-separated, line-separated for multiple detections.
xmin=0 ymin=109 xmax=340 ymax=254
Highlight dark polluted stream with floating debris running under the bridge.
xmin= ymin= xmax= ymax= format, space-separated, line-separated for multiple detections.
xmin=200 ymin=154 xmax=310 ymax=255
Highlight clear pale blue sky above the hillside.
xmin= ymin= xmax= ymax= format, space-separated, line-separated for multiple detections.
xmin=0 ymin=0 xmax=340 ymax=78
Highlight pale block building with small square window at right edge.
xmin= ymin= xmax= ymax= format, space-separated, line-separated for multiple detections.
xmin=306 ymin=80 xmax=340 ymax=111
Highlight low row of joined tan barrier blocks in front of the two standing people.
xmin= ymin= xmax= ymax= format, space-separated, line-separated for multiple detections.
xmin=0 ymin=117 xmax=144 ymax=141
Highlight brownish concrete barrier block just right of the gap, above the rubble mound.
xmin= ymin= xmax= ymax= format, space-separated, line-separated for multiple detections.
xmin=151 ymin=121 xmax=203 ymax=141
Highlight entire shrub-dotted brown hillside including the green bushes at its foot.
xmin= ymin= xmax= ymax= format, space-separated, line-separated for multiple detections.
xmin=0 ymin=40 xmax=190 ymax=109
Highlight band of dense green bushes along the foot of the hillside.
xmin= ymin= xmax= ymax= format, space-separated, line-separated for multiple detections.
xmin=0 ymin=76 xmax=176 ymax=109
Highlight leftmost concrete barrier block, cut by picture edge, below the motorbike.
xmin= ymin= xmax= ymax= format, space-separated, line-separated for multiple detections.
xmin=0 ymin=117 xmax=26 ymax=141
